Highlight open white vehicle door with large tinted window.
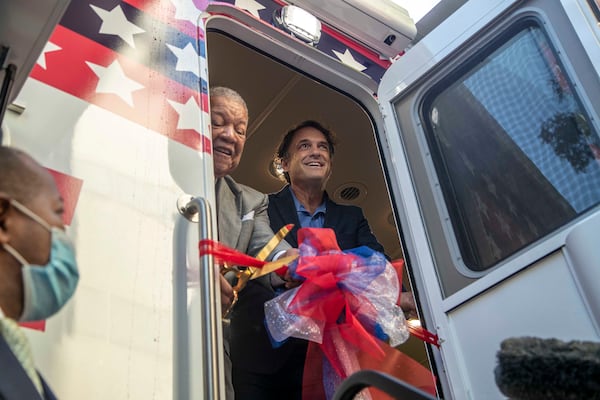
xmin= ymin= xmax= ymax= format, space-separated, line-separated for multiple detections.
xmin=378 ymin=0 xmax=600 ymax=399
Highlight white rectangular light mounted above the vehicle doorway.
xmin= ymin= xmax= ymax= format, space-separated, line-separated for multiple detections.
xmin=273 ymin=5 xmax=321 ymax=46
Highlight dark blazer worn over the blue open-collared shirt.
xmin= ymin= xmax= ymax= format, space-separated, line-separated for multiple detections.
xmin=231 ymin=186 xmax=383 ymax=374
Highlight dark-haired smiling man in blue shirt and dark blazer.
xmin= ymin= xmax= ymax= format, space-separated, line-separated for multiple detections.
xmin=232 ymin=121 xmax=410 ymax=400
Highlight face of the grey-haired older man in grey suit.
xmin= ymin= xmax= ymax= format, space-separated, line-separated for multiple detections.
xmin=210 ymin=96 xmax=248 ymax=178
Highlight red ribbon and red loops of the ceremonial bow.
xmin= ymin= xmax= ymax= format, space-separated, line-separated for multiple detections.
xmin=199 ymin=228 xmax=439 ymax=399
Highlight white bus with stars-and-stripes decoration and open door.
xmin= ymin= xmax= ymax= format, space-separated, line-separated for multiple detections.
xmin=0 ymin=0 xmax=600 ymax=400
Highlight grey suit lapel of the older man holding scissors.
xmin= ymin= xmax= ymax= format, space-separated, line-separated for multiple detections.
xmin=215 ymin=178 xmax=242 ymax=248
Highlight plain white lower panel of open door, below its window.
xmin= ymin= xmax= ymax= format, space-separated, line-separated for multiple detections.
xmin=447 ymin=251 xmax=600 ymax=400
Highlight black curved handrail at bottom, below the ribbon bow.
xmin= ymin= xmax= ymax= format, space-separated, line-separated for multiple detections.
xmin=333 ymin=369 xmax=435 ymax=400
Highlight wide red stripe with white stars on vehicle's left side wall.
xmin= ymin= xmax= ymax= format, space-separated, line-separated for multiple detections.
xmin=31 ymin=26 xmax=211 ymax=154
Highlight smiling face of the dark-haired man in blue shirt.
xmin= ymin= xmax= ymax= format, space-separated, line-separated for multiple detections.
xmin=281 ymin=127 xmax=331 ymax=187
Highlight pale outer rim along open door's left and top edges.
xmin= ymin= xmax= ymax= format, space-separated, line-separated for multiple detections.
xmin=378 ymin=0 xmax=514 ymax=399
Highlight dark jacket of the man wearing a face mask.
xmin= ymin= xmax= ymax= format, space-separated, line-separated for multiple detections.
xmin=0 ymin=335 xmax=56 ymax=400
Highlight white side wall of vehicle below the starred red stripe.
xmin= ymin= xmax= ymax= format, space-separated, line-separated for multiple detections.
xmin=6 ymin=80 xmax=206 ymax=400
